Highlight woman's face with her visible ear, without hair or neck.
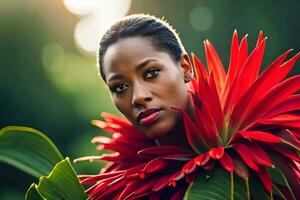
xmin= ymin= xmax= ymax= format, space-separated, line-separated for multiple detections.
xmin=103 ymin=37 xmax=191 ymax=139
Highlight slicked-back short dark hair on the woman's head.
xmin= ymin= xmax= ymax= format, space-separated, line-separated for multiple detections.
xmin=98 ymin=14 xmax=185 ymax=82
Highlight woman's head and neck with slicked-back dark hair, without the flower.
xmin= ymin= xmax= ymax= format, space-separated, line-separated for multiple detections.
xmin=99 ymin=15 xmax=193 ymax=147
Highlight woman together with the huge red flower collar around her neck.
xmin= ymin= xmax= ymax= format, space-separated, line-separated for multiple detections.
xmin=78 ymin=15 xmax=300 ymax=199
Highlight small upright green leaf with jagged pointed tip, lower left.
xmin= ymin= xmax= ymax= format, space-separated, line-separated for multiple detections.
xmin=26 ymin=158 xmax=87 ymax=200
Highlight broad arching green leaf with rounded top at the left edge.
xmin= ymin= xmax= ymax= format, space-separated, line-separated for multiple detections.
xmin=0 ymin=126 xmax=63 ymax=177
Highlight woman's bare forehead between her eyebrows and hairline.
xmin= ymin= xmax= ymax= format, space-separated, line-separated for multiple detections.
xmin=103 ymin=37 xmax=171 ymax=78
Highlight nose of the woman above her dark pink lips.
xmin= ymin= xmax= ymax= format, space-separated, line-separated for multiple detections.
xmin=132 ymin=84 xmax=152 ymax=107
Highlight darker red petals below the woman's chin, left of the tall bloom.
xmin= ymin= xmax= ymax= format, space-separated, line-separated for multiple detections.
xmin=77 ymin=113 xmax=194 ymax=199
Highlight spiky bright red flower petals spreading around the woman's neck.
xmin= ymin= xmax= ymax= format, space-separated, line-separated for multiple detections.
xmin=78 ymin=31 xmax=300 ymax=199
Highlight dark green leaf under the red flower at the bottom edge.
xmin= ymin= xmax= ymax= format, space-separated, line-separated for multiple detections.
xmin=184 ymin=168 xmax=247 ymax=200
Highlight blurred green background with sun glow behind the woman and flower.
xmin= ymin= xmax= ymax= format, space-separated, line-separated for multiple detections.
xmin=0 ymin=0 xmax=300 ymax=200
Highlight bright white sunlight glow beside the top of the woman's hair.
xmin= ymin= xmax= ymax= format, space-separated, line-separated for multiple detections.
xmin=64 ymin=0 xmax=131 ymax=54
